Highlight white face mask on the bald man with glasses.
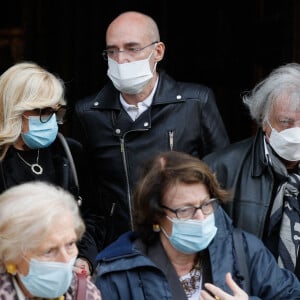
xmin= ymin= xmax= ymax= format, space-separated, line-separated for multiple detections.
xmin=107 ymin=50 xmax=156 ymax=95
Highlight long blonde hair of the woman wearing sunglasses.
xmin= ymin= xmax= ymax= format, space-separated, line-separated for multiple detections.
xmin=0 ymin=62 xmax=66 ymax=160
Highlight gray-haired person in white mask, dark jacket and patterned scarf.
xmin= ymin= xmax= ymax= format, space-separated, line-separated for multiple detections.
xmin=204 ymin=63 xmax=300 ymax=278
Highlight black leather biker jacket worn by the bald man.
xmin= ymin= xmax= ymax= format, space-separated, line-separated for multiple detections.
xmin=72 ymin=72 xmax=229 ymax=264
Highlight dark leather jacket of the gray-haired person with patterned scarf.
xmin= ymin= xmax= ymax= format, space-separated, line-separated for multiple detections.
xmin=203 ymin=129 xmax=274 ymax=238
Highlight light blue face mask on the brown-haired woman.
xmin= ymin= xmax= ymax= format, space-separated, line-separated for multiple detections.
xmin=161 ymin=214 xmax=217 ymax=254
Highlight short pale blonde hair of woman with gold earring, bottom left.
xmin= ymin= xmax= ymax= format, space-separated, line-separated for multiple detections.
xmin=0 ymin=181 xmax=85 ymax=272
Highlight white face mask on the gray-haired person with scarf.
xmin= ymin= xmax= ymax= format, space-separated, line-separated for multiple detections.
xmin=269 ymin=123 xmax=300 ymax=161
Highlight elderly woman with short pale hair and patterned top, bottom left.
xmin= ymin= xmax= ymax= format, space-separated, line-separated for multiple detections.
xmin=0 ymin=181 xmax=101 ymax=300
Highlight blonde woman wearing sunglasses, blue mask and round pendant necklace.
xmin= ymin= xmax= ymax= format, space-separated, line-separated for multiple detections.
xmin=0 ymin=62 xmax=80 ymax=193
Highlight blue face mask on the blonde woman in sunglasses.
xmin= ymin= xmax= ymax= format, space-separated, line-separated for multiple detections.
xmin=21 ymin=114 xmax=58 ymax=149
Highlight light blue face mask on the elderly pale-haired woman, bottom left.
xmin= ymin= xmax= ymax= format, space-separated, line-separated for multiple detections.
xmin=19 ymin=257 xmax=76 ymax=298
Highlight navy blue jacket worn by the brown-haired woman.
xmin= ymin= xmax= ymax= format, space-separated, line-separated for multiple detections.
xmin=96 ymin=207 xmax=300 ymax=300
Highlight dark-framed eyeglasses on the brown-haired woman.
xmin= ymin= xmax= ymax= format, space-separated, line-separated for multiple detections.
xmin=161 ymin=198 xmax=218 ymax=220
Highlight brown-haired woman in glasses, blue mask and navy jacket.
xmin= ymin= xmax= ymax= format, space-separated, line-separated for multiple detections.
xmin=96 ymin=151 xmax=300 ymax=300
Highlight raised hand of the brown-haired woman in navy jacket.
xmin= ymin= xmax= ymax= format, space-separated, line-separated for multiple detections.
xmin=200 ymin=273 xmax=249 ymax=300
